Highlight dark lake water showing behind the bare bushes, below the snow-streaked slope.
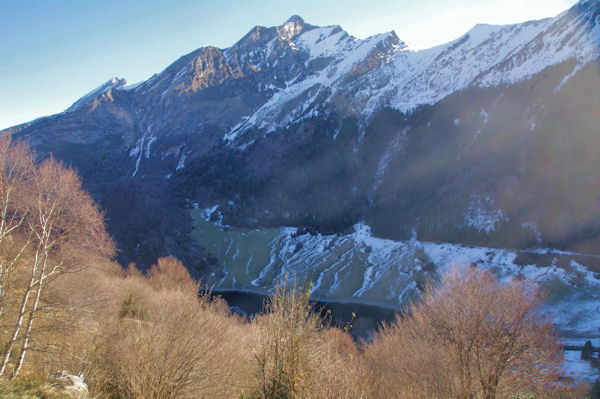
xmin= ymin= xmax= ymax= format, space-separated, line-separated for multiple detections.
xmin=213 ymin=290 xmax=399 ymax=340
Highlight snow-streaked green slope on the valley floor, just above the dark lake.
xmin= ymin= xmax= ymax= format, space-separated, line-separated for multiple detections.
xmin=193 ymin=207 xmax=600 ymax=338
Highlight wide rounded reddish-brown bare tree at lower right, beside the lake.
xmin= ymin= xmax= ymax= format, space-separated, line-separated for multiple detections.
xmin=367 ymin=267 xmax=562 ymax=399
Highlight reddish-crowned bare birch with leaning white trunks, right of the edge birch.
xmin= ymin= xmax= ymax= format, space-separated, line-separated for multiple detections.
xmin=0 ymin=144 xmax=114 ymax=376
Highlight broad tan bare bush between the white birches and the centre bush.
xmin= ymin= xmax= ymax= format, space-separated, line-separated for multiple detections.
xmin=86 ymin=268 xmax=250 ymax=399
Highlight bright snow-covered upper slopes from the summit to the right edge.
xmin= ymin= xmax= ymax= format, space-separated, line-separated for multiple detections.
xmin=225 ymin=2 xmax=600 ymax=140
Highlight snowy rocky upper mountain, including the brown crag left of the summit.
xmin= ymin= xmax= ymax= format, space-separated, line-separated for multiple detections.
xmin=111 ymin=1 xmax=600 ymax=141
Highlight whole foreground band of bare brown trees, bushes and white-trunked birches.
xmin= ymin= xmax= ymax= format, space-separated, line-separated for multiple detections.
xmin=0 ymin=138 xmax=585 ymax=399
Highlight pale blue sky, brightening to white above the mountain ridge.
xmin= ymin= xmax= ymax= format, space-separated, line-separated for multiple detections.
xmin=0 ymin=0 xmax=576 ymax=129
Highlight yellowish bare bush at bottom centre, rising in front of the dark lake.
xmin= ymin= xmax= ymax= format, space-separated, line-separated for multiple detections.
xmin=247 ymin=285 xmax=365 ymax=399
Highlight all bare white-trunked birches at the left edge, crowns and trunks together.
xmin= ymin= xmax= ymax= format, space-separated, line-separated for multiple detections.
xmin=0 ymin=137 xmax=114 ymax=377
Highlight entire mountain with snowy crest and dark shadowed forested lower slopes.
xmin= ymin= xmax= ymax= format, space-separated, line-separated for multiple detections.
xmin=3 ymin=0 xmax=600 ymax=276
